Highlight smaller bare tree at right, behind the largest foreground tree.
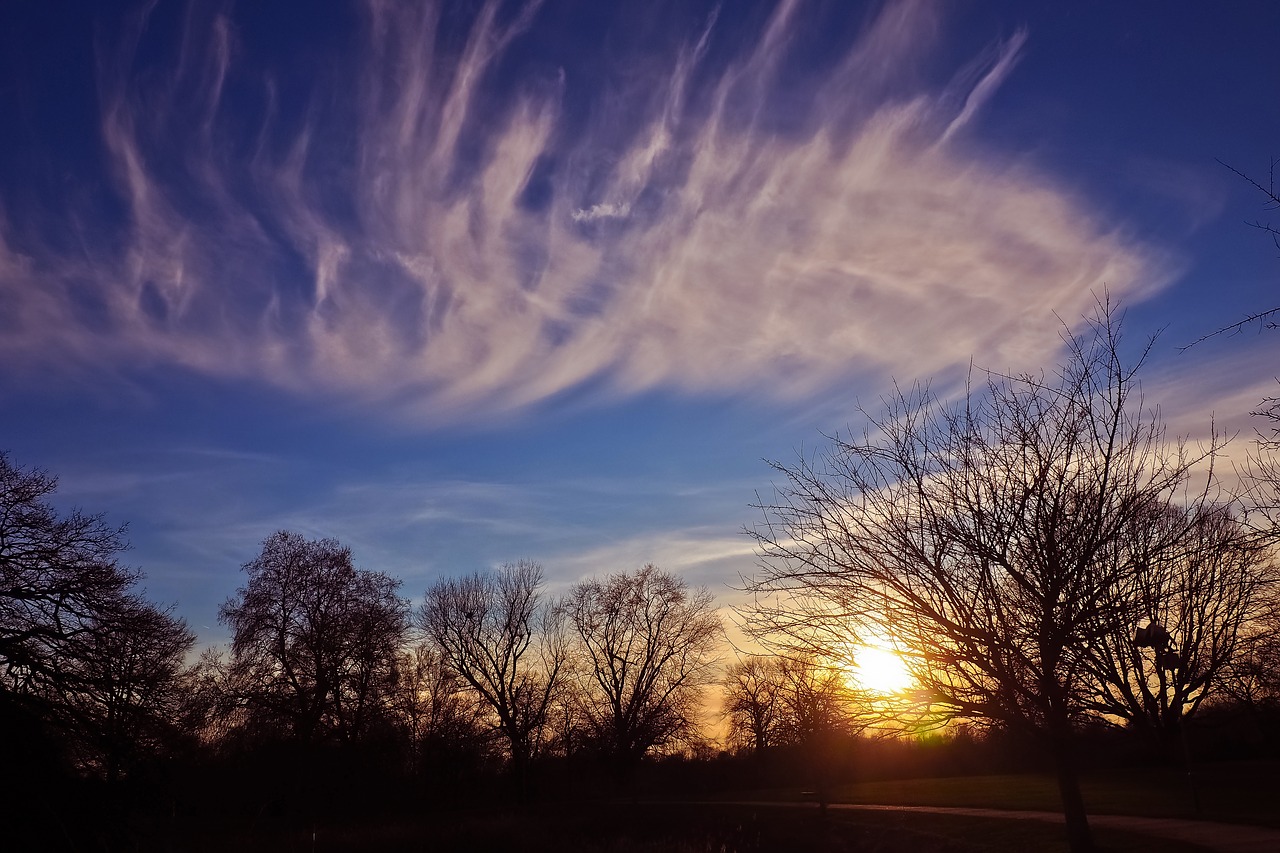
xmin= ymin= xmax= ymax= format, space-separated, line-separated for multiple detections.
xmin=1082 ymin=506 xmax=1276 ymax=753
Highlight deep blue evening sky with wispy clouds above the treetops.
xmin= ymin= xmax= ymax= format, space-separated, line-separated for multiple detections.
xmin=0 ymin=0 xmax=1280 ymax=643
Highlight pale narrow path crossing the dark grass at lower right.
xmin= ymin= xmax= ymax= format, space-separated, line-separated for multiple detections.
xmin=824 ymin=803 xmax=1280 ymax=853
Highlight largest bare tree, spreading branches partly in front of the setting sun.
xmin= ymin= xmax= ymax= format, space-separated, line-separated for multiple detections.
xmin=749 ymin=306 xmax=1216 ymax=850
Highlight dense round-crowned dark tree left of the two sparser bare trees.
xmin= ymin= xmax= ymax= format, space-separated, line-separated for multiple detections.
xmin=219 ymin=532 xmax=408 ymax=742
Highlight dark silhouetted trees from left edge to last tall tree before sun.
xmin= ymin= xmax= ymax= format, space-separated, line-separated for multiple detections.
xmin=0 ymin=453 xmax=723 ymax=834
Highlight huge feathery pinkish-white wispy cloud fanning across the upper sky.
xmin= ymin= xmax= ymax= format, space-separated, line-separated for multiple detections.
xmin=0 ymin=0 xmax=1174 ymax=420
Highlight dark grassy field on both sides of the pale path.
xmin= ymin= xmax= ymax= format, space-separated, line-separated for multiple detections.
xmin=154 ymin=762 xmax=1280 ymax=853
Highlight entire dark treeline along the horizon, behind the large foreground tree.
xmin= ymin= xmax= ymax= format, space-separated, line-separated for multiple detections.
xmin=0 ymin=438 xmax=1280 ymax=849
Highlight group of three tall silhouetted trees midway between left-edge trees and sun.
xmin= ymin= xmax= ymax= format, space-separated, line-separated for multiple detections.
xmin=188 ymin=532 xmax=722 ymax=788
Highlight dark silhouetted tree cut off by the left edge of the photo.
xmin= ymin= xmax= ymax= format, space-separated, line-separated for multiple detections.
xmin=0 ymin=452 xmax=195 ymax=780
